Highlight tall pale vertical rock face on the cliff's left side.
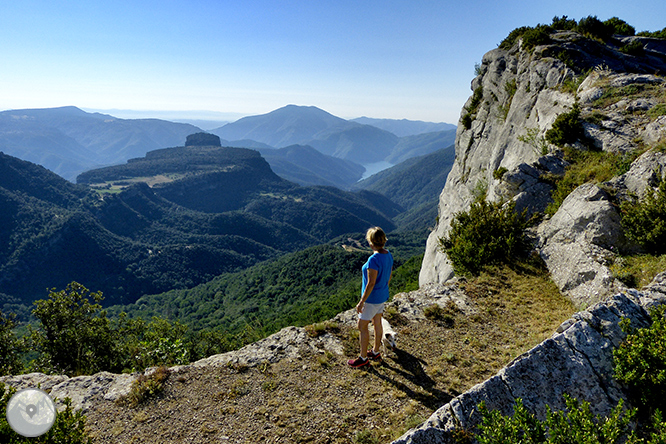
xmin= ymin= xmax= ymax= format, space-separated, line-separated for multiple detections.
xmin=419 ymin=42 xmax=575 ymax=285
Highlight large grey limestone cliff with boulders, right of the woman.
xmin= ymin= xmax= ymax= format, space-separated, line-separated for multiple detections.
xmin=420 ymin=31 xmax=666 ymax=306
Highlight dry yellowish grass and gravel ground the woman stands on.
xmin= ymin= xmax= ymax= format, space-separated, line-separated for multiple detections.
xmin=81 ymin=267 xmax=574 ymax=443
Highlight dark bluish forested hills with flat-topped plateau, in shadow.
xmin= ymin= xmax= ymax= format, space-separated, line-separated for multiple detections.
xmin=0 ymin=143 xmax=412 ymax=312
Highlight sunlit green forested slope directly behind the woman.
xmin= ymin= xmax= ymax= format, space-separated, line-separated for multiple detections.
xmin=109 ymin=230 xmax=427 ymax=351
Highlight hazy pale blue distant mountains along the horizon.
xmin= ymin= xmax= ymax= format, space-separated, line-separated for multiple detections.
xmin=0 ymin=105 xmax=455 ymax=183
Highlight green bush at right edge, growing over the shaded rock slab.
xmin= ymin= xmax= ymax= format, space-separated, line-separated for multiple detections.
xmin=613 ymin=306 xmax=666 ymax=411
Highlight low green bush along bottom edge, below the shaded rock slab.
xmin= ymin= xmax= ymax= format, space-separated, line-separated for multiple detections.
xmin=478 ymin=394 xmax=637 ymax=444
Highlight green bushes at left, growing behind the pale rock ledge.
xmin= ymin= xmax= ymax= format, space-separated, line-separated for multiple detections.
xmin=30 ymin=282 xmax=191 ymax=375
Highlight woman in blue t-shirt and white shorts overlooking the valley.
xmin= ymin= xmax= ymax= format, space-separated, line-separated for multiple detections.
xmin=347 ymin=227 xmax=393 ymax=368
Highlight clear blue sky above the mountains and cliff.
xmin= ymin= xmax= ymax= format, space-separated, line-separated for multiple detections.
xmin=0 ymin=0 xmax=666 ymax=124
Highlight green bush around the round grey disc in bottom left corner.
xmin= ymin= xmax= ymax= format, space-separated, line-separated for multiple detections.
xmin=0 ymin=383 xmax=92 ymax=444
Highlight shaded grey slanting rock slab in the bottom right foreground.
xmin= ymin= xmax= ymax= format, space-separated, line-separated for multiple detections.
xmin=394 ymin=273 xmax=666 ymax=444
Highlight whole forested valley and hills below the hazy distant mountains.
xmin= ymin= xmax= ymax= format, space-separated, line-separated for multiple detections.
xmin=0 ymin=135 xmax=452 ymax=373
